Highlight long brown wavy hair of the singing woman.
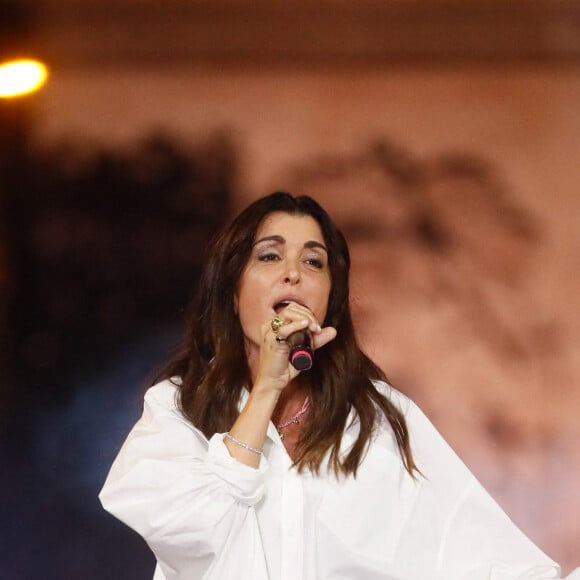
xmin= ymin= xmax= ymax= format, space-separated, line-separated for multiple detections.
xmin=157 ymin=192 xmax=418 ymax=476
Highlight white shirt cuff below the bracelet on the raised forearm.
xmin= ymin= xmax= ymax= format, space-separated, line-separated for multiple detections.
xmin=205 ymin=433 xmax=268 ymax=506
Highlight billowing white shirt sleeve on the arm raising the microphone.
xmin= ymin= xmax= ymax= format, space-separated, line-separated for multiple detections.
xmin=99 ymin=381 xmax=267 ymax=580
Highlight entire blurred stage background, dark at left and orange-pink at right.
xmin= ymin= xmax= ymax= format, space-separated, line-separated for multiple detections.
xmin=0 ymin=0 xmax=580 ymax=580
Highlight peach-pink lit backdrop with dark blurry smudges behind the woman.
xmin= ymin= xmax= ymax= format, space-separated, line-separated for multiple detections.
xmin=35 ymin=66 xmax=580 ymax=571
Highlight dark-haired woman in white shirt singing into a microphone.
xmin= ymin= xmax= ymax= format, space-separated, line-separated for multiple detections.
xmin=100 ymin=193 xmax=580 ymax=580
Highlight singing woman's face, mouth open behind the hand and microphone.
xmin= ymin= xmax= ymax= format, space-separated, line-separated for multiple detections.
xmin=236 ymin=212 xmax=331 ymax=357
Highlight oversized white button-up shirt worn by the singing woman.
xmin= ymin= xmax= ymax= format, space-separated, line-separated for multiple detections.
xmin=100 ymin=381 xmax=580 ymax=580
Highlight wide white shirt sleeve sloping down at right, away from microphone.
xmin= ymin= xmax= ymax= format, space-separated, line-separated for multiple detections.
xmin=398 ymin=394 xmax=574 ymax=580
